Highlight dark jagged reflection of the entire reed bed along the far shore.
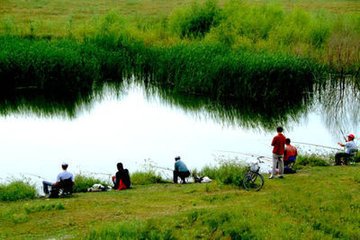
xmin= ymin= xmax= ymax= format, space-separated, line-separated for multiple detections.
xmin=0 ymin=77 xmax=312 ymax=129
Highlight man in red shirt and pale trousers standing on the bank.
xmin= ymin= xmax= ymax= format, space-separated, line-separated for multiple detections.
xmin=269 ymin=127 xmax=286 ymax=179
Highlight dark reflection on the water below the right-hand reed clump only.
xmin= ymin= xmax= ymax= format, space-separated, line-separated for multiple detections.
xmin=143 ymin=85 xmax=311 ymax=130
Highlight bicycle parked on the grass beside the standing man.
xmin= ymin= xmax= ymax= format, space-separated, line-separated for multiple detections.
xmin=243 ymin=156 xmax=264 ymax=191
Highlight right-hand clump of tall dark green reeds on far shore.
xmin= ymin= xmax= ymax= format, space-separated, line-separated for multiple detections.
xmin=147 ymin=43 xmax=320 ymax=104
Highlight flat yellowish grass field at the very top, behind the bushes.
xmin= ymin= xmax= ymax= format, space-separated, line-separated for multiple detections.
xmin=0 ymin=0 xmax=360 ymax=36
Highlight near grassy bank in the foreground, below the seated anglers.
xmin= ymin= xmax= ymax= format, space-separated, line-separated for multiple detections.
xmin=0 ymin=165 xmax=360 ymax=239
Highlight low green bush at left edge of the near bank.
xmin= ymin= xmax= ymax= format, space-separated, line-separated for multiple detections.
xmin=0 ymin=180 xmax=37 ymax=201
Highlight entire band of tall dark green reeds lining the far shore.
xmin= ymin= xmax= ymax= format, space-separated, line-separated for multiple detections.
xmin=0 ymin=36 xmax=318 ymax=103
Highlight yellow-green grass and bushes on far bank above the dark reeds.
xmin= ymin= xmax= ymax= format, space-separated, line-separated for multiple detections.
xmin=0 ymin=0 xmax=360 ymax=73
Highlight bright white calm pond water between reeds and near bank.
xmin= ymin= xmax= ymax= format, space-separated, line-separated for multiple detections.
xmin=0 ymin=79 xmax=360 ymax=187
